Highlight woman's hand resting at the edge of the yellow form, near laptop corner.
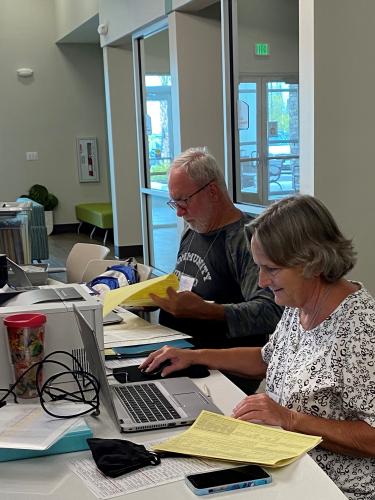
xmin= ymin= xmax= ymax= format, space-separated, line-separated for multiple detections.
xmin=232 ymin=394 xmax=294 ymax=430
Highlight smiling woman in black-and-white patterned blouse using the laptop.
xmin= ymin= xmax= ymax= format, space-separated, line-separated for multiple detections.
xmin=142 ymin=196 xmax=375 ymax=500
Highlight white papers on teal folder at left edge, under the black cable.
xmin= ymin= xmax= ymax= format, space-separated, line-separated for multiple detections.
xmin=0 ymin=403 xmax=80 ymax=450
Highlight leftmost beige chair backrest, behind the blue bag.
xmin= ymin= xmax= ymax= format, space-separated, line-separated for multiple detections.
xmin=66 ymin=243 xmax=110 ymax=283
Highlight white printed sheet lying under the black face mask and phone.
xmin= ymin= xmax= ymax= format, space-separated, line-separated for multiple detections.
xmin=69 ymin=457 xmax=223 ymax=499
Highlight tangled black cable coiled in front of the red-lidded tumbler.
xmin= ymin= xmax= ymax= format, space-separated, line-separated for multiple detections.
xmin=0 ymin=351 xmax=100 ymax=418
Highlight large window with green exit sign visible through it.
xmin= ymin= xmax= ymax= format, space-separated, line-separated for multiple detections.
xmin=222 ymin=0 xmax=300 ymax=207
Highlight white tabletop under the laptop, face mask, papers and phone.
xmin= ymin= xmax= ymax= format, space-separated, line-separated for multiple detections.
xmin=0 ymin=312 xmax=346 ymax=500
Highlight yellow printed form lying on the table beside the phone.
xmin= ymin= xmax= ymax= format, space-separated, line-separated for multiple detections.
xmin=153 ymin=411 xmax=322 ymax=467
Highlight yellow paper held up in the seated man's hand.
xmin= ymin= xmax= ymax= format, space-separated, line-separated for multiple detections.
xmin=103 ymin=274 xmax=179 ymax=316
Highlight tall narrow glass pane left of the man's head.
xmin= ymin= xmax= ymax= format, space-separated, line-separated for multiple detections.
xmin=133 ymin=23 xmax=179 ymax=274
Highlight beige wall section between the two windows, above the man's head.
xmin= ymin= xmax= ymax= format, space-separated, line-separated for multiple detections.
xmin=169 ymin=12 xmax=224 ymax=168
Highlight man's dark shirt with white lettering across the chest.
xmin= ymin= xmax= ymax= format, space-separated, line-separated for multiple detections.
xmin=159 ymin=214 xmax=282 ymax=348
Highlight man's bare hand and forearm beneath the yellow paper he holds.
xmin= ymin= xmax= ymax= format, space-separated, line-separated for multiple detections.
xmin=150 ymin=287 xmax=224 ymax=320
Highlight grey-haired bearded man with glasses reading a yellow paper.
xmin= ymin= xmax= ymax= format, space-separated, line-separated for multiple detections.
xmin=151 ymin=148 xmax=282 ymax=392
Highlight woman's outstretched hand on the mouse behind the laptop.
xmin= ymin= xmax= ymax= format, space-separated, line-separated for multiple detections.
xmin=139 ymin=346 xmax=195 ymax=377
